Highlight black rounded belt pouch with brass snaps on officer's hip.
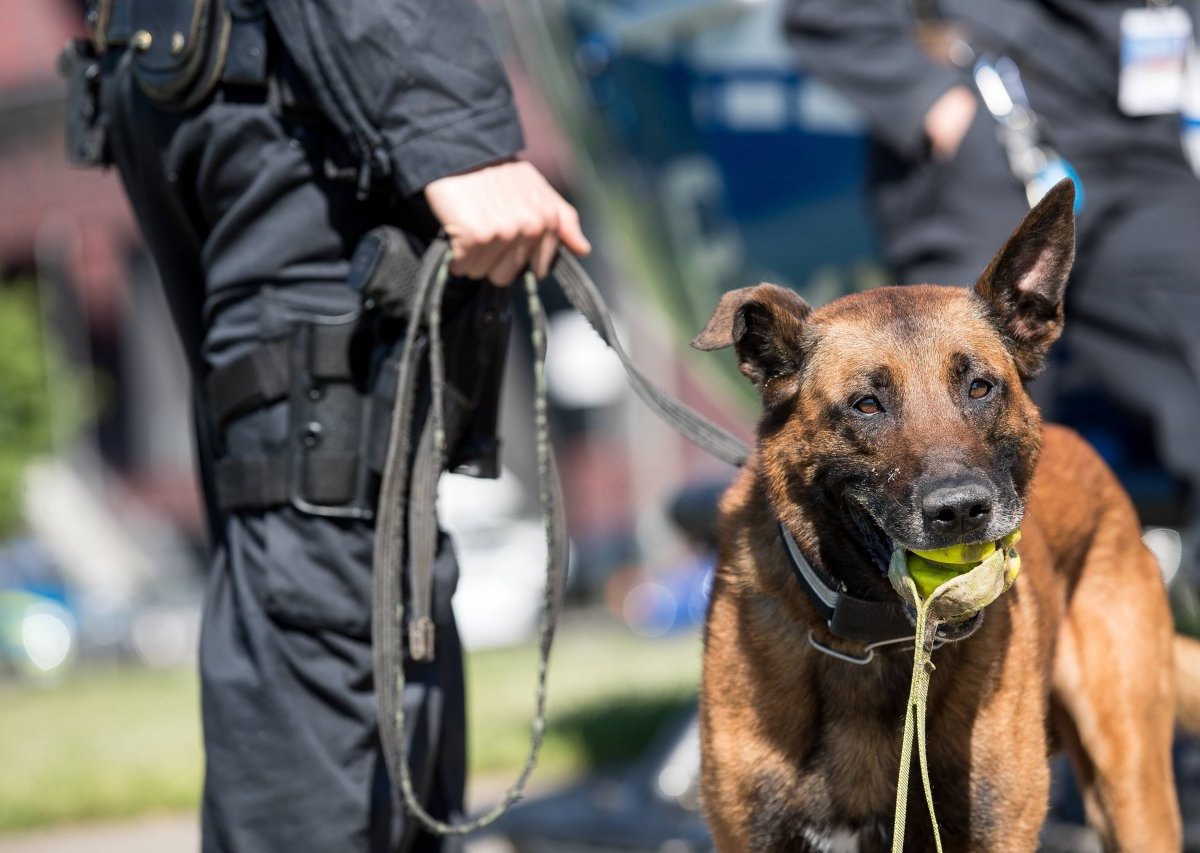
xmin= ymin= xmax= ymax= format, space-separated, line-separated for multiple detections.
xmin=130 ymin=0 xmax=230 ymax=110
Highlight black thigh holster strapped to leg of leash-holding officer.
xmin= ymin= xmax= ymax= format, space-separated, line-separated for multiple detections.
xmin=205 ymin=227 xmax=511 ymax=518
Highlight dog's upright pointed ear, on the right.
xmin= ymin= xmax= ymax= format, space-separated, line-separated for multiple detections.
xmin=976 ymin=179 xmax=1075 ymax=379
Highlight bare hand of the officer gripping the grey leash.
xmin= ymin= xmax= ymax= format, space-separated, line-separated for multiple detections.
xmin=425 ymin=161 xmax=592 ymax=284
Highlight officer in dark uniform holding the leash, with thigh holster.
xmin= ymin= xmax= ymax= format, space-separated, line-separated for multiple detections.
xmin=68 ymin=0 xmax=589 ymax=853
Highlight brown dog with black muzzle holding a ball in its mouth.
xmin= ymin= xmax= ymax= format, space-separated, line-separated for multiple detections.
xmin=694 ymin=181 xmax=1200 ymax=853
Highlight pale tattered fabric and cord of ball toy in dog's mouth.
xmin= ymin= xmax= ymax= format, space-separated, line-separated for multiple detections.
xmin=888 ymin=530 xmax=1021 ymax=853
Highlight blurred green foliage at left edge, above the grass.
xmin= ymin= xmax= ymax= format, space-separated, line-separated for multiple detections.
xmin=0 ymin=282 xmax=52 ymax=537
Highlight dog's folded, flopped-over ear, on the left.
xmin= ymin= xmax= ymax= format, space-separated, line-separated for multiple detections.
xmin=691 ymin=284 xmax=812 ymax=391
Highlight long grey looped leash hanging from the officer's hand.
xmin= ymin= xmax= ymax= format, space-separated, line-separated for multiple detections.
xmin=372 ymin=240 xmax=749 ymax=835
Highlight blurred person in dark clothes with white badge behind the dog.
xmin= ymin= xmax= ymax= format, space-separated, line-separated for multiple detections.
xmin=786 ymin=0 xmax=1200 ymax=581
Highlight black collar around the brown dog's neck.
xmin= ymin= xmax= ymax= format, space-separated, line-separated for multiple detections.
xmin=779 ymin=523 xmax=983 ymax=656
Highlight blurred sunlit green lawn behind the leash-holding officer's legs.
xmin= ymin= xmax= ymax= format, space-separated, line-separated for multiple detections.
xmin=0 ymin=614 xmax=700 ymax=831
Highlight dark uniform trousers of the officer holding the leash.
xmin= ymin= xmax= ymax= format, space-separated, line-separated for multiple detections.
xmin=102 ymin=51 xmax=466 ymax=853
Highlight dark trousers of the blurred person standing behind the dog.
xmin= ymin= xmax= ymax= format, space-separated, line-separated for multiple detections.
xmin=871 ymin=106 xmax=1200 ymax=579
